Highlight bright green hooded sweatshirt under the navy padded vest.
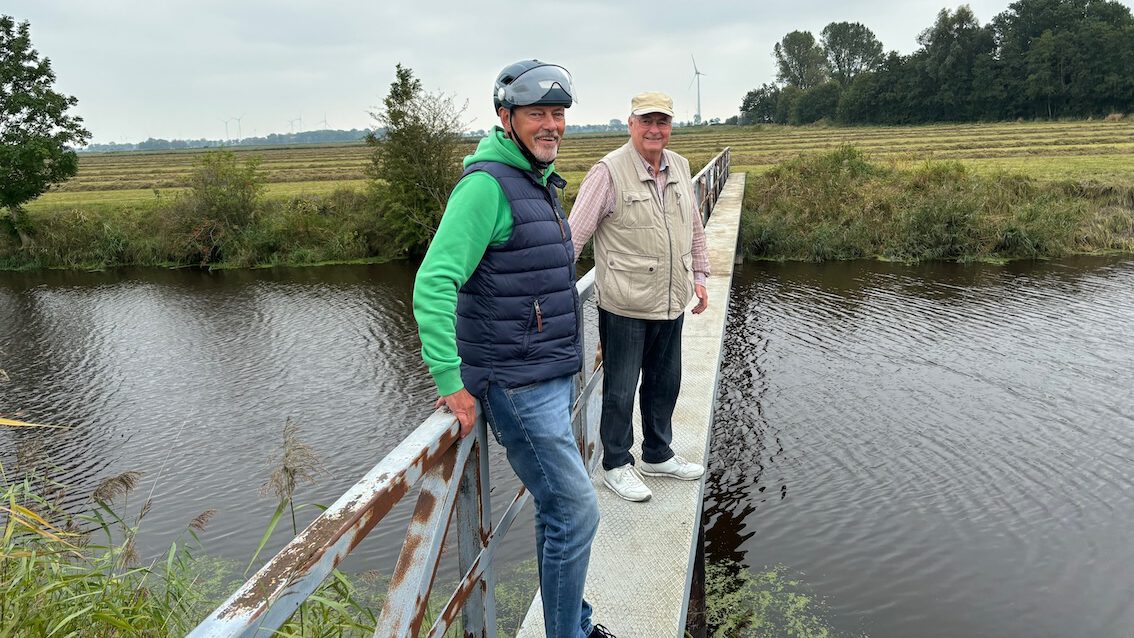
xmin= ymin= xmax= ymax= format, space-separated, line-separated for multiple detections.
xmin=414 ymin=127 xmax=555 ymax=397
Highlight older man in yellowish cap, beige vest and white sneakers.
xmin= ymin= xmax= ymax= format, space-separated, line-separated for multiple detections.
xmin=568 ymin=92 xmax=709 ymax=501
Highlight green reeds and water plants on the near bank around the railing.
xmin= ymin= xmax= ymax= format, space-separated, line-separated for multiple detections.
xmin=0 ymin=422 xmax=828 ymax=638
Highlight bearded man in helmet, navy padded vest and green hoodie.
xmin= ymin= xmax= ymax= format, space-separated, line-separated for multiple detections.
xmin=414 ymin=60 xmax=610 ymax=638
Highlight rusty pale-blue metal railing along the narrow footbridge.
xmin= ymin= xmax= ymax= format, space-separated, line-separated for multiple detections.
xmin=188 ymin=148 xmax=729 ymax=638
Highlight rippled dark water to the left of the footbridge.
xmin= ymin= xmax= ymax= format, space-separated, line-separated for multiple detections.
xmin=0 ymin=264 xmax=533 ymax=570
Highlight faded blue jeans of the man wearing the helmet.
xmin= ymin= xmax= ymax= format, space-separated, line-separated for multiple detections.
xmin=481 ymin=375 xmax=599 ymax=638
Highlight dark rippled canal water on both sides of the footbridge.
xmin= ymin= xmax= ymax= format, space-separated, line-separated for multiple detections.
xmin=0 ymin=260 xmax=1134 ymax=638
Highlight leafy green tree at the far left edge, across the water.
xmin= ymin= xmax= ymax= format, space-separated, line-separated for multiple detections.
xmin=0 ymin=15 xmax=91 ymax=247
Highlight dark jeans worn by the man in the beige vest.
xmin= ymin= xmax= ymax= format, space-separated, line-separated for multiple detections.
xmin=599 ymin=308 xmax=685 ymax=469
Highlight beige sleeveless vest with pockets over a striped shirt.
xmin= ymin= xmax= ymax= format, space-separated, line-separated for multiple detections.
xmin=594 ymin=142 xmax=693 ymax=320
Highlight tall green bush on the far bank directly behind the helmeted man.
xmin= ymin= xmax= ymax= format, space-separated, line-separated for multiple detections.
xmin=366 ymin=65 xmax=465 ymax=255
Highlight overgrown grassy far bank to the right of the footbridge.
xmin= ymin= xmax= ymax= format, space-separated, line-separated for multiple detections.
xmin=741 ymin=146 xmax=1134 ymax=262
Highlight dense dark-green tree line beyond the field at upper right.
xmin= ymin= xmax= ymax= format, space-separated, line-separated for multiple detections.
xmin=738 ymin=0 xmax=1134 ymax=125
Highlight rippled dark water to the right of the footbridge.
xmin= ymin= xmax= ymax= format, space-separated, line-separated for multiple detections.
xmin=705 ymin=260 xmax=1134 ymax=638
